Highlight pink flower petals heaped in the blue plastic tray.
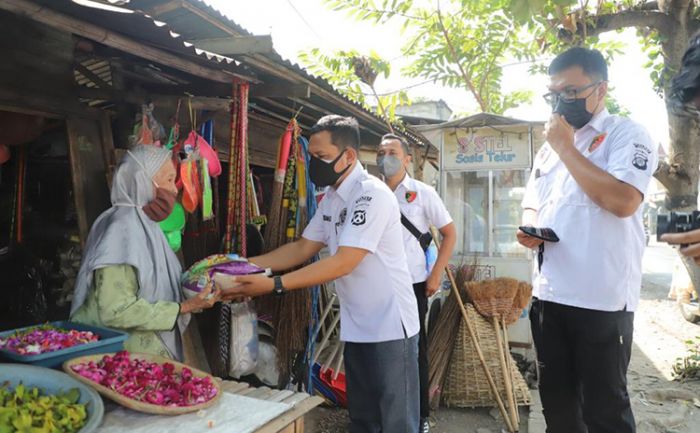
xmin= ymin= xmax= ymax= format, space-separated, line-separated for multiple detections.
xmin=0 ymin=325 xmax=100 ymax=355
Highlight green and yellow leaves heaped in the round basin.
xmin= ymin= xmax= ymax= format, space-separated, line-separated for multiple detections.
xmin=0 ymin=384 xmax=88 ymax=433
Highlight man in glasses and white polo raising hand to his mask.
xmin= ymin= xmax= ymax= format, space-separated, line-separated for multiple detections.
xmin=517 ymin=47 xmax=658 ymax=433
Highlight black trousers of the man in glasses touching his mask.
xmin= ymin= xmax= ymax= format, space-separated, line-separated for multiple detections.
xmin=530 ymin=299 xmax=635 ymax=433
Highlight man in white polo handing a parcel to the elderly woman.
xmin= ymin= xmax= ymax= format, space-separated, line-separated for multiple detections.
xmin=224 ymin=116 xmax=419 ymax=433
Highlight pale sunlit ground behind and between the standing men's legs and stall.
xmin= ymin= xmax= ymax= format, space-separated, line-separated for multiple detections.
xmin=306 ymin=240 xmax=700 ymax=433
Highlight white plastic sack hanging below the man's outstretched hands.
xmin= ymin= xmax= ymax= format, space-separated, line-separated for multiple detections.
xmin=229 ymin=302 xmax=259 ymax=379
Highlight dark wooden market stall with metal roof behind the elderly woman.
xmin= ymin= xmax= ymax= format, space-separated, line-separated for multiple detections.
xmin=0 ymin=0 xmax=436 ymax=431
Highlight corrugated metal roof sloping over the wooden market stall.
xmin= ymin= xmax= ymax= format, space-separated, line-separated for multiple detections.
xmin=33 ymin=0 xmax=429 ymax=144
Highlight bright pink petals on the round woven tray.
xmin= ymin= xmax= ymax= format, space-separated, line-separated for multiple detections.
xmin=70 ymin=351 xmax=219 ymax=407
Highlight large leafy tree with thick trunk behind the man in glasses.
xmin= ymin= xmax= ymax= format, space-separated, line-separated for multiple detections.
xmin=325 ymin=0 xmax=700 ymax=287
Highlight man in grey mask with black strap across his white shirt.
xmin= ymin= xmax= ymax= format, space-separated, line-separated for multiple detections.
xmin=377 ymin=134 xmax=457 ymax=433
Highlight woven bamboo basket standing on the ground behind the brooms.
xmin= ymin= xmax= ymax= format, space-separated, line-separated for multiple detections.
xmin=442 ymin=304 xmax=530 ymax=408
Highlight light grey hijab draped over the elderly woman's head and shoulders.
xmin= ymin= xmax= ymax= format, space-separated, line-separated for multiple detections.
xmin=71 ymin=145 xmax=190 ymax=360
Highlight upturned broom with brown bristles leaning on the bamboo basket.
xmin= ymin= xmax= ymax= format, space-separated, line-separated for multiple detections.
xmin=467 ymin=278 xmax=519 ymax=431
